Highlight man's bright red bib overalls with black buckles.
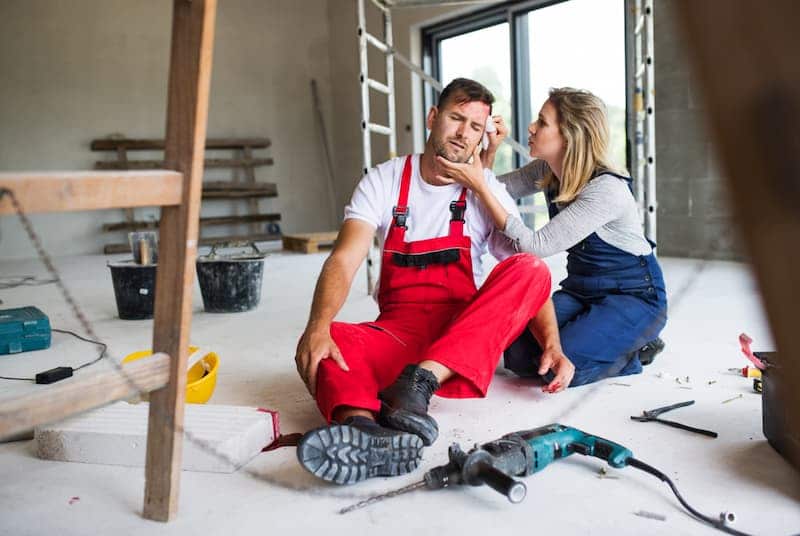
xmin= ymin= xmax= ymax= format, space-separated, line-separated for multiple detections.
xmin=316 ymin=156 xmax=550 ymax=422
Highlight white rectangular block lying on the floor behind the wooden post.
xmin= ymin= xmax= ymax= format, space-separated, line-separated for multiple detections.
xmin=35 ymin=402 xmax=277 ymax=473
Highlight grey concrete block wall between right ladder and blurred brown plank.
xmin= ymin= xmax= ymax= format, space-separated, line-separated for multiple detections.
xmin=654 ymin=0 xmax=741 ymax=259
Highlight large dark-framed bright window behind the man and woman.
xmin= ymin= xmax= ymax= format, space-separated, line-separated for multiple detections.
xmin=423 ymin=0 xmax=628 ymax=227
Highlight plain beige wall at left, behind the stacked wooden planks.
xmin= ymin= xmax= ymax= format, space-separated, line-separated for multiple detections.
xmin=0 ymin=0 xmax=332 ymax=258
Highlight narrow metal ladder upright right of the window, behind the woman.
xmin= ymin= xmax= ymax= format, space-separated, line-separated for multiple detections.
xmin=633 ymin=0 xmax=658 ymax=242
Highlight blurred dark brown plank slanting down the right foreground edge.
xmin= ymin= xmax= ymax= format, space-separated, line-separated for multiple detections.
xmin=676 ymin=0 xmax=800 ymax=468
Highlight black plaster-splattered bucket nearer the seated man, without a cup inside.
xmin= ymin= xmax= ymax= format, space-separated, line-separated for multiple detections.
xmin=197 ymin=243 xmax=266 ymax=313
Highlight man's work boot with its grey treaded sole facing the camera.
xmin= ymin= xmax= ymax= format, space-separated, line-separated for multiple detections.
xmin=297 ymin=416 xmax=422 ymax=484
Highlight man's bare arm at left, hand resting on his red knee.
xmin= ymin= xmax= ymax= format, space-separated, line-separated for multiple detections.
xmin=295 ymin=219 xmax=375 ymax=395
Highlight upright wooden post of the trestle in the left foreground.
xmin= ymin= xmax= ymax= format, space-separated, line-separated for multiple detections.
xmin=143 ymin=0 xmax=216 ymax=521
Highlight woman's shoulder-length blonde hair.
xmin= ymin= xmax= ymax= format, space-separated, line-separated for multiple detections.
xmin=540 ymin=87 xmax=618 ymax=203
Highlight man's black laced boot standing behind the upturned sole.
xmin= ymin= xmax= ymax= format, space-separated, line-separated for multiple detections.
xmin=378 ymin=365 xmax=439 ymax=446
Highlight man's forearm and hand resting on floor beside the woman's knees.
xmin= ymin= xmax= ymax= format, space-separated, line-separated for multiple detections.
xmin=528 ymin=299 xmax=575 ymax=393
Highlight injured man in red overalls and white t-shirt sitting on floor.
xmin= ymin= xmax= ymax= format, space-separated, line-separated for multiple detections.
xmin=295 ymin=78 xmax=574 ymax=484
